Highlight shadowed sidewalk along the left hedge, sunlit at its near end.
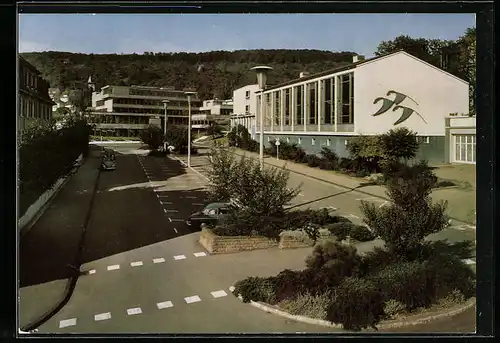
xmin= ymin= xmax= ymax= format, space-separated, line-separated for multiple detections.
xmin=18 ymin=148 xmax=100 ymax=326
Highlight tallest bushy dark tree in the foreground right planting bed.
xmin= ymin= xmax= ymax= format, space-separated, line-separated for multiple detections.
xmin=361 ymin=161 xmax=448 ymax=258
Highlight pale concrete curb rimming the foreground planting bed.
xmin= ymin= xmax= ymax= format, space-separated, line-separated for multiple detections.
xmin=229 ymin=286 xmax=476 ymax=330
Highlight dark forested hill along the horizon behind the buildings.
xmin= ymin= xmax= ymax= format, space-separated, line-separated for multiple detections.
xmin=21 ymin=49 xmax=356 ymax=99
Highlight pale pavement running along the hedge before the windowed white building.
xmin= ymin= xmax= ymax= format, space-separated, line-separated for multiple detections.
xmin=233 ymin=148 xmax=476 ymax=225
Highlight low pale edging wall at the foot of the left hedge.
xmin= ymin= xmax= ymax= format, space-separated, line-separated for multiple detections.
xmin=17 ymin=154 xmax=83 ymax=236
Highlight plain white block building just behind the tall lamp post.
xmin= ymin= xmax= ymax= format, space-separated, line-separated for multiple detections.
xmin=231 ymin=84 xmax=259 ymax=138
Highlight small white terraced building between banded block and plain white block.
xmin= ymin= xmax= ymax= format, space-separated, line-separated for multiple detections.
xmin=191 ymin=99 xmax=233 ymax=130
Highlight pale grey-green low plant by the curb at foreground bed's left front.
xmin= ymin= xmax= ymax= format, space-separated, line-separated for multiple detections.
xmin=278 ymin=292 xmax=333 ymax=320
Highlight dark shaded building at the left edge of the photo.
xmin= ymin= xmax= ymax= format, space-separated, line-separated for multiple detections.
xmin=18 ymin=57 xmax=54 ymax=131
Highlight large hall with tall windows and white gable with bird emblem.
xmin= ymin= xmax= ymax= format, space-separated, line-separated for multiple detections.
xmin=256 ymin=51 xmax=469 ymax=163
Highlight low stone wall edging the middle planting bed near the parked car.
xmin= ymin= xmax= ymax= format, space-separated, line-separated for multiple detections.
xmin=199 ymin=226 xmax=335 ymax=254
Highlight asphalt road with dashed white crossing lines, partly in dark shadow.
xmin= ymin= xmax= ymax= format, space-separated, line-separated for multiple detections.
xmin=33 ymin=145 xmax=342 ymax=333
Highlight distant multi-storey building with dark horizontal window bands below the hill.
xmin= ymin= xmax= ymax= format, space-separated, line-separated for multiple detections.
xmin=90 ymin=85 xmax=201 ymax=137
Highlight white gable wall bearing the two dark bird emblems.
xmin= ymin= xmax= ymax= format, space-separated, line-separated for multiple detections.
xmin=354 ymin=52 xmax=469 ymax=136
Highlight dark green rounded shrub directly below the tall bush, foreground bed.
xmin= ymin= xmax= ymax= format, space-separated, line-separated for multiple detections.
xmin=373 ymin=261 xmax=435 ymax=311
